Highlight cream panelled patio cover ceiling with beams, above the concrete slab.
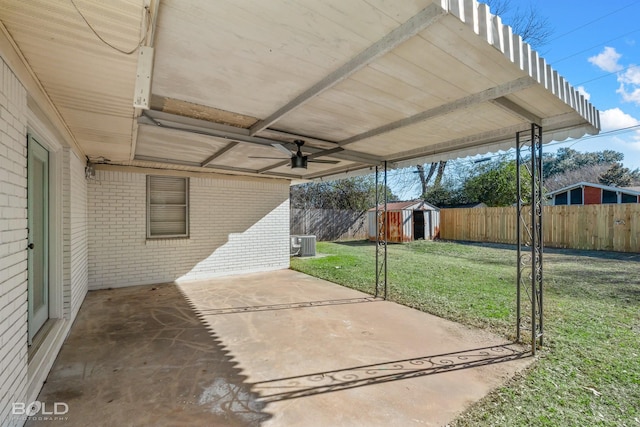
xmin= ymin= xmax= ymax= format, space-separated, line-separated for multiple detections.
xmin=0 ymin=0 xmax=600 ymax=180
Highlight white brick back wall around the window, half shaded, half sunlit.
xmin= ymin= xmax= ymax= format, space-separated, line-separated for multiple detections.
xmin=88 ymin=170 xmax=289 ymax=289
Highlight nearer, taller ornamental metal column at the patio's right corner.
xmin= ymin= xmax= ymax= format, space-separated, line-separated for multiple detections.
xmin=516 ymin=124 xmax=544 ymax=355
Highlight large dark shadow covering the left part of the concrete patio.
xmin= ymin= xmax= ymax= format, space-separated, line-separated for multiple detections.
xmin=27 ymin=284 xmax=271 ymax=427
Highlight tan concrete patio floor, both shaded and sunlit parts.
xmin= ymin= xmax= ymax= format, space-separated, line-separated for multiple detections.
xmin=27 ymin=270 xmax=532 ymax=426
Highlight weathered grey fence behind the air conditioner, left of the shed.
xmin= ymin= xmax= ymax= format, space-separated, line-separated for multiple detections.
xmin=290 ymin=209 xmax=368 ymax=241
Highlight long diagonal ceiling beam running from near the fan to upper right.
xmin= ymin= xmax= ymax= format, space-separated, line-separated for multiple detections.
xmin=249 ymin=3 xmax=447 ymax=135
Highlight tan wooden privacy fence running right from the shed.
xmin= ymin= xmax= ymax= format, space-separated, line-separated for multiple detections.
xmin=440 ymin=203 xmax=640 ymax=252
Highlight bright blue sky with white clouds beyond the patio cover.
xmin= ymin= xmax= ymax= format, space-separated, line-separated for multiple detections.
xmin=512 ymin=0 xmax=640 ymax=169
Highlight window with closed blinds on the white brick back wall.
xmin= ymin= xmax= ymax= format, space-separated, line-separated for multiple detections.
xmin=147 ymin=175 xmax=189 ymax=238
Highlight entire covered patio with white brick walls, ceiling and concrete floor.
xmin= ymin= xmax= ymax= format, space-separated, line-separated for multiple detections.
xmin=0 ymin=0 xmax=600 ymax=426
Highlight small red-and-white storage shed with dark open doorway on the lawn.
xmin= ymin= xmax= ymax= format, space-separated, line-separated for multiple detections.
xmin=367 ymin=200 xmax=440 ymax=243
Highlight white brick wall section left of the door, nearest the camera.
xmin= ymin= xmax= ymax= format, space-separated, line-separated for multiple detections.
xmin=0 ymin=60 xmax=27 ymax=425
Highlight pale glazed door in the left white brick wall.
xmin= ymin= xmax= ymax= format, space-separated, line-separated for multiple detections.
xmin=27 ymin=136 xmax=49 ymax=344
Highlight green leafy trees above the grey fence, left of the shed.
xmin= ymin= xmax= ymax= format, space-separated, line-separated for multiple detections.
xmin=290 ymin=175 xmax=396 ymax=211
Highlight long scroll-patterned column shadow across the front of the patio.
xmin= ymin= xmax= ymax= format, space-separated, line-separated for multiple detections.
xmin=252 ymin=343 xmax=531 ymax=403
